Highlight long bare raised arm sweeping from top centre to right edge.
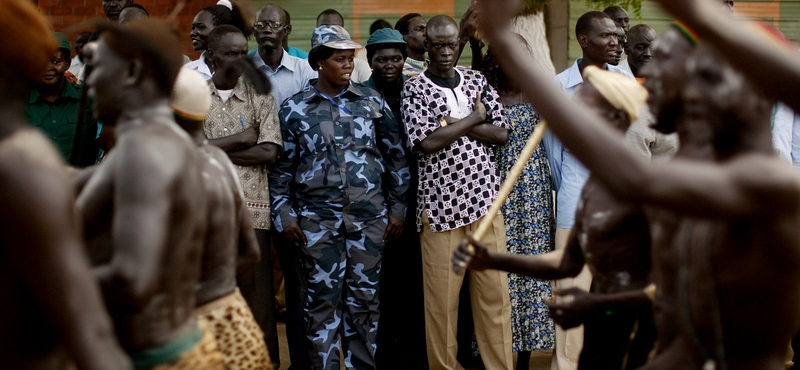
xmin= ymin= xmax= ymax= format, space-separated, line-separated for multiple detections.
xmin=480 ymin=0 xmax=798 ymax=217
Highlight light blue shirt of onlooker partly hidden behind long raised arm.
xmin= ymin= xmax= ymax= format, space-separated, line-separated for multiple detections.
xmin=542 ymin=59 xmax=635 ymax=229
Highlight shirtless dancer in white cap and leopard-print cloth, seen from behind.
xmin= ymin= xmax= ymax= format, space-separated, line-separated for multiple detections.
xmin=172 ymin=68 xmax=272 ymax=370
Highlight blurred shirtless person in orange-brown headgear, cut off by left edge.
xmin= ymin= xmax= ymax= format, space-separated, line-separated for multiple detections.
xmin=0 ymin=0 xmax=130 ymax=370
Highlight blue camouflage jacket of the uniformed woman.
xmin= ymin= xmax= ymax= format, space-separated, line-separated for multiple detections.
xmin=269 ymin=80 xmax=410 ymax=232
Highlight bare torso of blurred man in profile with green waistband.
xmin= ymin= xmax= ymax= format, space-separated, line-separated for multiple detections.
xmin=78 ymin=114 xmax=206 ymax=353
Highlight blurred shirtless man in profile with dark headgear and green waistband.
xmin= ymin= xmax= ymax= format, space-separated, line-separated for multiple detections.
xmin=78 ymin=19 xmax=225 ymax=370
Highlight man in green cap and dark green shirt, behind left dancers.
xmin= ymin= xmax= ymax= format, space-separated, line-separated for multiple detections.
xmin=25 ymin=32 xmax=98 ymax=167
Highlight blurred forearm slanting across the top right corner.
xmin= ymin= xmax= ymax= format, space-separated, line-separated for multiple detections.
xmin=657 ymin=0 xmax=800 ymax=112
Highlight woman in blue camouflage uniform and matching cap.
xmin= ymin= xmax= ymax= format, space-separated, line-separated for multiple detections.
xmin=269 ymin=26 xmax=409 ymax=369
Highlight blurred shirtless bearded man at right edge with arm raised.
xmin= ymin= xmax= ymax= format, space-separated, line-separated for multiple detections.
xmin=472 ymin=1 xmax=800 ymax=369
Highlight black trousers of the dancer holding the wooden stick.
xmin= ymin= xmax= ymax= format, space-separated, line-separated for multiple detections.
xmin=578 ymin=307 xmax=656 ymax=370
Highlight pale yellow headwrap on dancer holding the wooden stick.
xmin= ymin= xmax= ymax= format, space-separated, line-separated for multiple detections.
xmin=583 ymin=66 xmax=647 ymax=122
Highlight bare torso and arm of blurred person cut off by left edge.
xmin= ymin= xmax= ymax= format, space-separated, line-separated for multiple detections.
xmin=0 ymin=127 xmax=126 ymax=370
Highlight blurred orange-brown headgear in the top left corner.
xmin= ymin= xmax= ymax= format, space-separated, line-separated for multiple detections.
xmin=0 ymin=0 xmax=57 ymax=80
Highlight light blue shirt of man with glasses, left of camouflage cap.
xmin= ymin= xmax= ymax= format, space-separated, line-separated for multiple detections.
xmin=250 ymin=51 xmax=317 ymax=106
